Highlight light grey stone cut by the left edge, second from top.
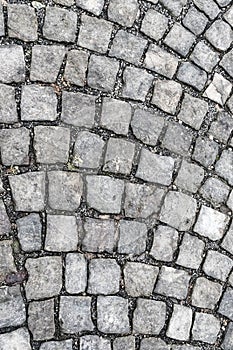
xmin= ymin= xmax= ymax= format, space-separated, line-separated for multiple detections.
xmin=0 ymin=45 xmax=25 ymax=84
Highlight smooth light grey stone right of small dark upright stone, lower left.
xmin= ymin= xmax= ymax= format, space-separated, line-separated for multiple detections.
xmin=45 ymin=215 xmax=78 ymax=252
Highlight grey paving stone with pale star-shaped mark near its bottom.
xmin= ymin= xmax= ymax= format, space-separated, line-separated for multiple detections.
xmin=103 ymin=137 xmax=135 ymax=174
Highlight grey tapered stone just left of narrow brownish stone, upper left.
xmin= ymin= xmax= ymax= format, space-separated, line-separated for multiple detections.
xmin=30 ymin=45 xmax=66 ymax=83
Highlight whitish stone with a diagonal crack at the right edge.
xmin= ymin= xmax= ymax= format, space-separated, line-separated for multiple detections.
xmin=203 ymin=73 xmax=233 ymax=106
